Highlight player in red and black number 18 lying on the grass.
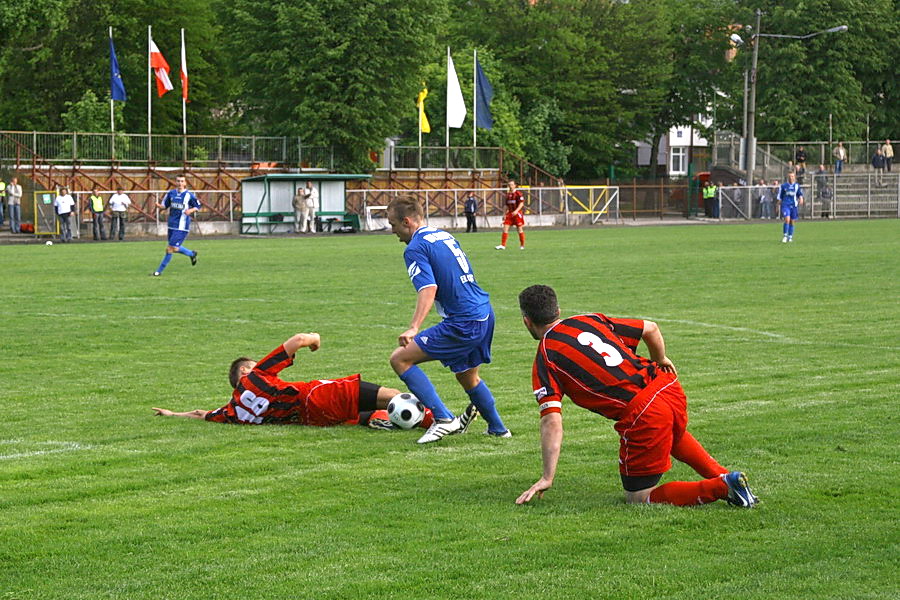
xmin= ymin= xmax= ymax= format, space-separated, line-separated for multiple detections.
xmin=153 ymin=333 xmax=432 ymax=429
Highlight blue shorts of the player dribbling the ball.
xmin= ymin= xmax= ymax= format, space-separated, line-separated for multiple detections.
xmin=413 ymin=311 xmax=494 ymax=373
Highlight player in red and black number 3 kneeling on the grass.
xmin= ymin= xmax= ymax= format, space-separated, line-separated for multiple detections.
xmin=516 ymin=285 xmax=758 ymax=508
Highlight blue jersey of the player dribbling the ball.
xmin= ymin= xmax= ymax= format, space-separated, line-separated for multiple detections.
xmin=403 ymin=227 xmax=491 ymax=321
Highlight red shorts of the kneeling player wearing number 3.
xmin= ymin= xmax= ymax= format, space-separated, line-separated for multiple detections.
xmin=615 ymin=375 xmax=687 ymax=477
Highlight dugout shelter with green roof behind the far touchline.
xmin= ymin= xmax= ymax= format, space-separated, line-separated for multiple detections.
xmin=241 ymin=173 xmax=372 ymax=234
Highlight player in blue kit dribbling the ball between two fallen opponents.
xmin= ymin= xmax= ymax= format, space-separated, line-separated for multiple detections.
xmin=387 ymin=198 xmax=512 ymax=444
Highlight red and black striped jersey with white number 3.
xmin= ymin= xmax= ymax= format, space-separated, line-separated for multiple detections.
xmin=532 ymin=313 xmax=661 ymax=421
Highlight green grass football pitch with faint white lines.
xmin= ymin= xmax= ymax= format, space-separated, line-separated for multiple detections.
xmin=0 ymin=220 xmax=900 ymax=600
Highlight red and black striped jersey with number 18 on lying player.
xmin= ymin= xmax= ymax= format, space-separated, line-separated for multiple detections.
xmin=206 ymin=345 xmax=358 ymax=425
